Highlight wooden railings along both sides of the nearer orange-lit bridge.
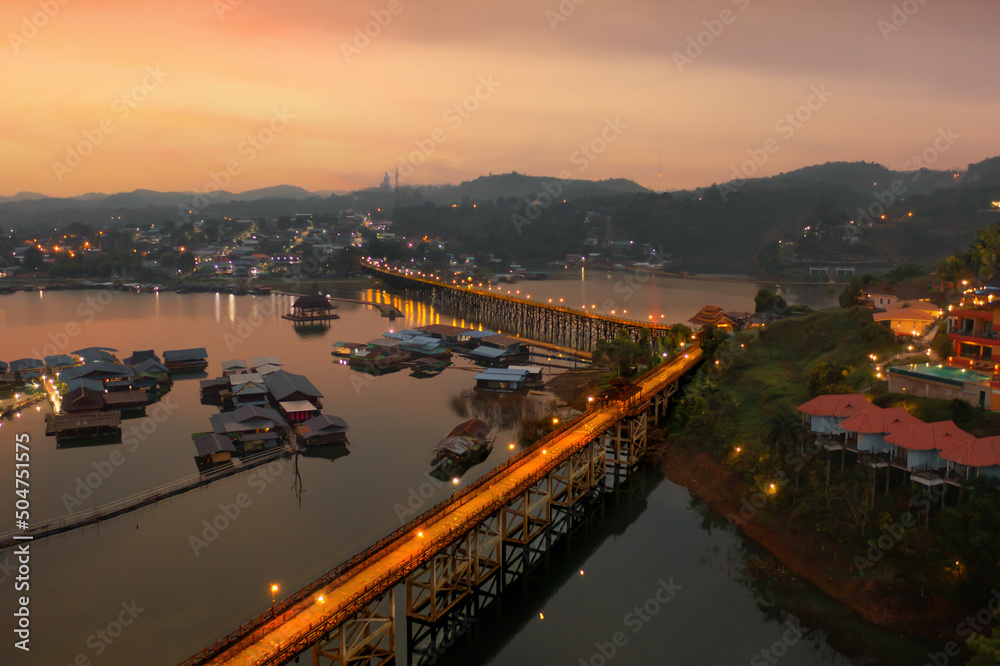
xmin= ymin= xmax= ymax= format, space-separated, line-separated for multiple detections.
xmin=180 ymin=348 xmax=700 ymax=666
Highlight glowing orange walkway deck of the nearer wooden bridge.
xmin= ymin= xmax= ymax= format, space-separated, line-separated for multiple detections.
xmin=201 ymin=348 xmax=701 ymax=666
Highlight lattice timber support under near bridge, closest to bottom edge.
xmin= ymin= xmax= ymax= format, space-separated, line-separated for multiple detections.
xmin=312 ymin=590 xmax=396 ymax=666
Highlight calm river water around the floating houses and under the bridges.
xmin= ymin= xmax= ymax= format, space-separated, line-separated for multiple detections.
xmin=0 ymin=274 xmax=952 ymax=666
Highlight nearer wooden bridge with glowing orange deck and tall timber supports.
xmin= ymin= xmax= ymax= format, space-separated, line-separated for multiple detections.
xmin=182 ymin=347 xmax=702 ymax=666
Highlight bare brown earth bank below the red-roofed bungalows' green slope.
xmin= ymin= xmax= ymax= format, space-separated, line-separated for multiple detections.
xmin=650 ymin=430 xmax=975 ymax=642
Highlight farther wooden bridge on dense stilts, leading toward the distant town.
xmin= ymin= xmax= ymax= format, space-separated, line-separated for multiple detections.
xmin=362 ymin=262 xmax=671 ymax=351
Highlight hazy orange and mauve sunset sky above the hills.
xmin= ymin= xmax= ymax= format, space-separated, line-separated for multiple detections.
xmin=0 ymin=0 xmax=1000 ymax=196
